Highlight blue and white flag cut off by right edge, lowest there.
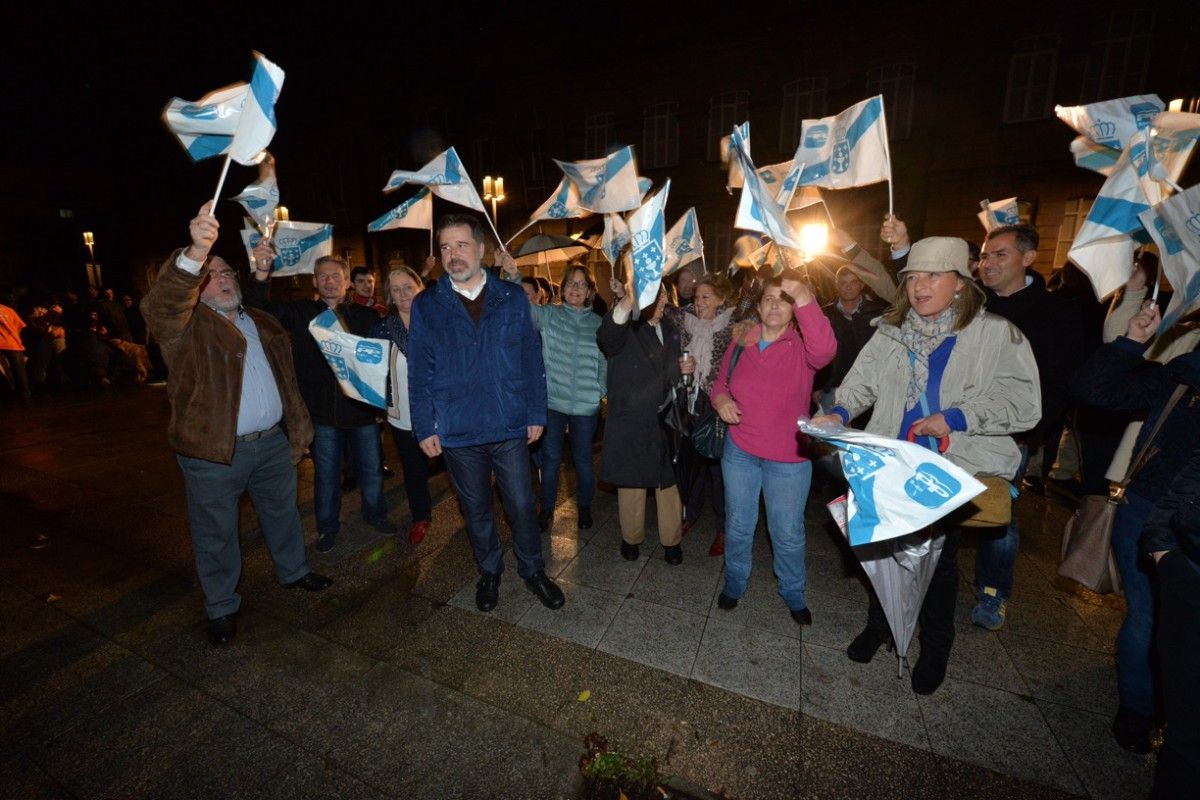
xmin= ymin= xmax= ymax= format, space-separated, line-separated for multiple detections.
xmin=1138 ymin=184 xmax=1200 ymax=331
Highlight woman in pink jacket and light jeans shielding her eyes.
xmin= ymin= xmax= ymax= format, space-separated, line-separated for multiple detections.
xmin=713 ymin=277 xmax=838 ymax=625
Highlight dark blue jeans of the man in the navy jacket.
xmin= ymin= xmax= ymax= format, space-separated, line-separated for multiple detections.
xmin=442 ymin=439 xmax=546 ymax=578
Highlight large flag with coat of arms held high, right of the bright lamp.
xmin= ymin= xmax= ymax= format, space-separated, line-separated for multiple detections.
xmin=796 ymin=95 xmax=892 ymax=188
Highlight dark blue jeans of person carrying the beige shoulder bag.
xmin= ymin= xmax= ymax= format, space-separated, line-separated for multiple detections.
xmin=1112 ymin=494 xmax=1158 ymax=717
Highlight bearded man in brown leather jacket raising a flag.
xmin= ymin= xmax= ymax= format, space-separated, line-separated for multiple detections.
xmin=142 ymin=203 xmax=332 ymax=644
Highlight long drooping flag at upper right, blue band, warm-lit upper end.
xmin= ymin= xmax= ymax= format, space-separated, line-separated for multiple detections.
xmin=1068 ymin=112 xmax=1200 ymax=299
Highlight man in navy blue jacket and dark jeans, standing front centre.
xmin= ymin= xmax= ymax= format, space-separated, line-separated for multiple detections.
xmin=408 ymin=213 xmax=563 ymax=612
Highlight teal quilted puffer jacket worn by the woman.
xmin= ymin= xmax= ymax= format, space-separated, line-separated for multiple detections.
xmin=530 ymin=303 xmax=608 ymax=416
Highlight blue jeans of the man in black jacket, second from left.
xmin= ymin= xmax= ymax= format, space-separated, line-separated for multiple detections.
xmin=312 ymin=422 xmax=388 ymax=534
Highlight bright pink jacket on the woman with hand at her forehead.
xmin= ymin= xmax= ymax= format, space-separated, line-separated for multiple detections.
xmin=713 ymin=302 xmax=838 ymax=462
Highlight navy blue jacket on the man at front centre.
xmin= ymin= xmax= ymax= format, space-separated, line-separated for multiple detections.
xmin=408 ymin=273 xmax=546 ymax=447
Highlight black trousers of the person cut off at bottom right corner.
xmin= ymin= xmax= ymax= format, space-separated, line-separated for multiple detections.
xmin=1151 ymin=551 xmax=1200 ymax=800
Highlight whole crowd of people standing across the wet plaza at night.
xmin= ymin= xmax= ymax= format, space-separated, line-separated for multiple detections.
xmin=9 ymin=195 xmax=1200 ymax=796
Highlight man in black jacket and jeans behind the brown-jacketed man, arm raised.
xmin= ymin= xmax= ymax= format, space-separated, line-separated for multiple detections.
xmin=246 ymin=253 xmax=398 ymax=553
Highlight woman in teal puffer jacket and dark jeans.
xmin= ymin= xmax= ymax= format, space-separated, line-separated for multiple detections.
xmin=529 ymin=264 xmax=607 ymax=530
